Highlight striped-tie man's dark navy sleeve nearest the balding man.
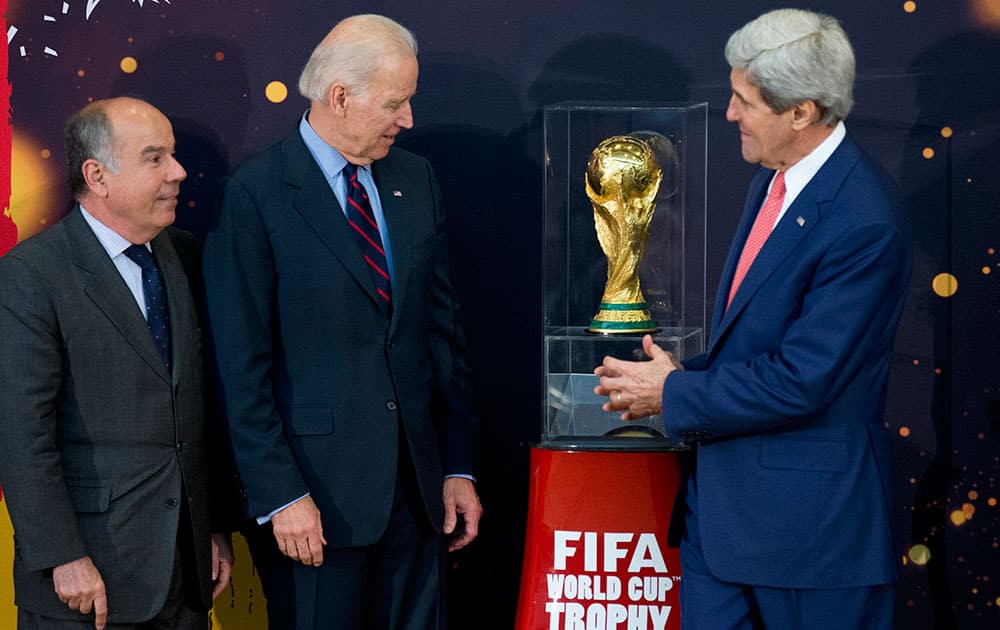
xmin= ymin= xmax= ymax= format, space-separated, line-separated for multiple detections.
xmin=202 ymin=179 xmax=309 ymax=516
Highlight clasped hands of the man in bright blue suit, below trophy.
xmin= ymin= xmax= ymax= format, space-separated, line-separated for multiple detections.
xmin=594 ymin=335 xmax=683 ymax=420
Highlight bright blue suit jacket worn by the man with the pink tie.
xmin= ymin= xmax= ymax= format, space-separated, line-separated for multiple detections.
xmin=663 ymin=138 xmax=911 ymax=588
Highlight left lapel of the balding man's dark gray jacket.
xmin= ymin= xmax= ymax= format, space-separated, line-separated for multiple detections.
xmin=66 ymin=208 xmax=170 ymax=383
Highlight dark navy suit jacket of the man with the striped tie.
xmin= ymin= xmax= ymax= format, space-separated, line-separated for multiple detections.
xmin=204 ymin=129 xmax=475 ymax=547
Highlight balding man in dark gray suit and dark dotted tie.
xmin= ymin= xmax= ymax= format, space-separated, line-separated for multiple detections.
xmin=0 ymin=98 xmax=233 ymax=630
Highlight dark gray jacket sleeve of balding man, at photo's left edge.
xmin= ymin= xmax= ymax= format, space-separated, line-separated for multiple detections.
xmin=0 ymin=254 xmax=88 ymax=571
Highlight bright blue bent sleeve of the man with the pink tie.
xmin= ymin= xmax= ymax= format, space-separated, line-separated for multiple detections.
xmin=663 ymin=217 xmax=909 ymax=437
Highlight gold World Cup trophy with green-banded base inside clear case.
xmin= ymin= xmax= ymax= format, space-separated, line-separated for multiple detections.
xmin=584 ymin=136 xmax=663 ymax=334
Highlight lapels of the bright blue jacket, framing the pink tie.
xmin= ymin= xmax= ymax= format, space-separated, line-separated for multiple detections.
xmin=708 ymin=138 xmax=858 ymax=352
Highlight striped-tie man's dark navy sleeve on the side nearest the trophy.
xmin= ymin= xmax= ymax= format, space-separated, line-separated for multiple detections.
xmin=427 ymin=164 xmax=478 ymax=475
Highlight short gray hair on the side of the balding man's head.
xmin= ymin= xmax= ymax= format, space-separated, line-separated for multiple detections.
xmin=66 ymin=101 xmax=120 ymax=197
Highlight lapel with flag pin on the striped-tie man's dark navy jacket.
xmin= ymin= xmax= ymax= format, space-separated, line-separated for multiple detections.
xmin=372 ymin=152 xmax=412 ymax=334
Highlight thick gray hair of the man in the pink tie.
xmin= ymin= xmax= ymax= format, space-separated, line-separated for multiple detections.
xmin=726 ymin=9 xmax=854 ymax=124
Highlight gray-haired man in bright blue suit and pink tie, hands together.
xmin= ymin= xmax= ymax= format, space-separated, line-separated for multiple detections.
xmin=595 ymin=10 xmax=911 ymax=630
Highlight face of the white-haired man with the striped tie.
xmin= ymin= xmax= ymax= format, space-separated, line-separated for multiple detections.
xmin=332 ymin=54 xmax=419 ymax=164
